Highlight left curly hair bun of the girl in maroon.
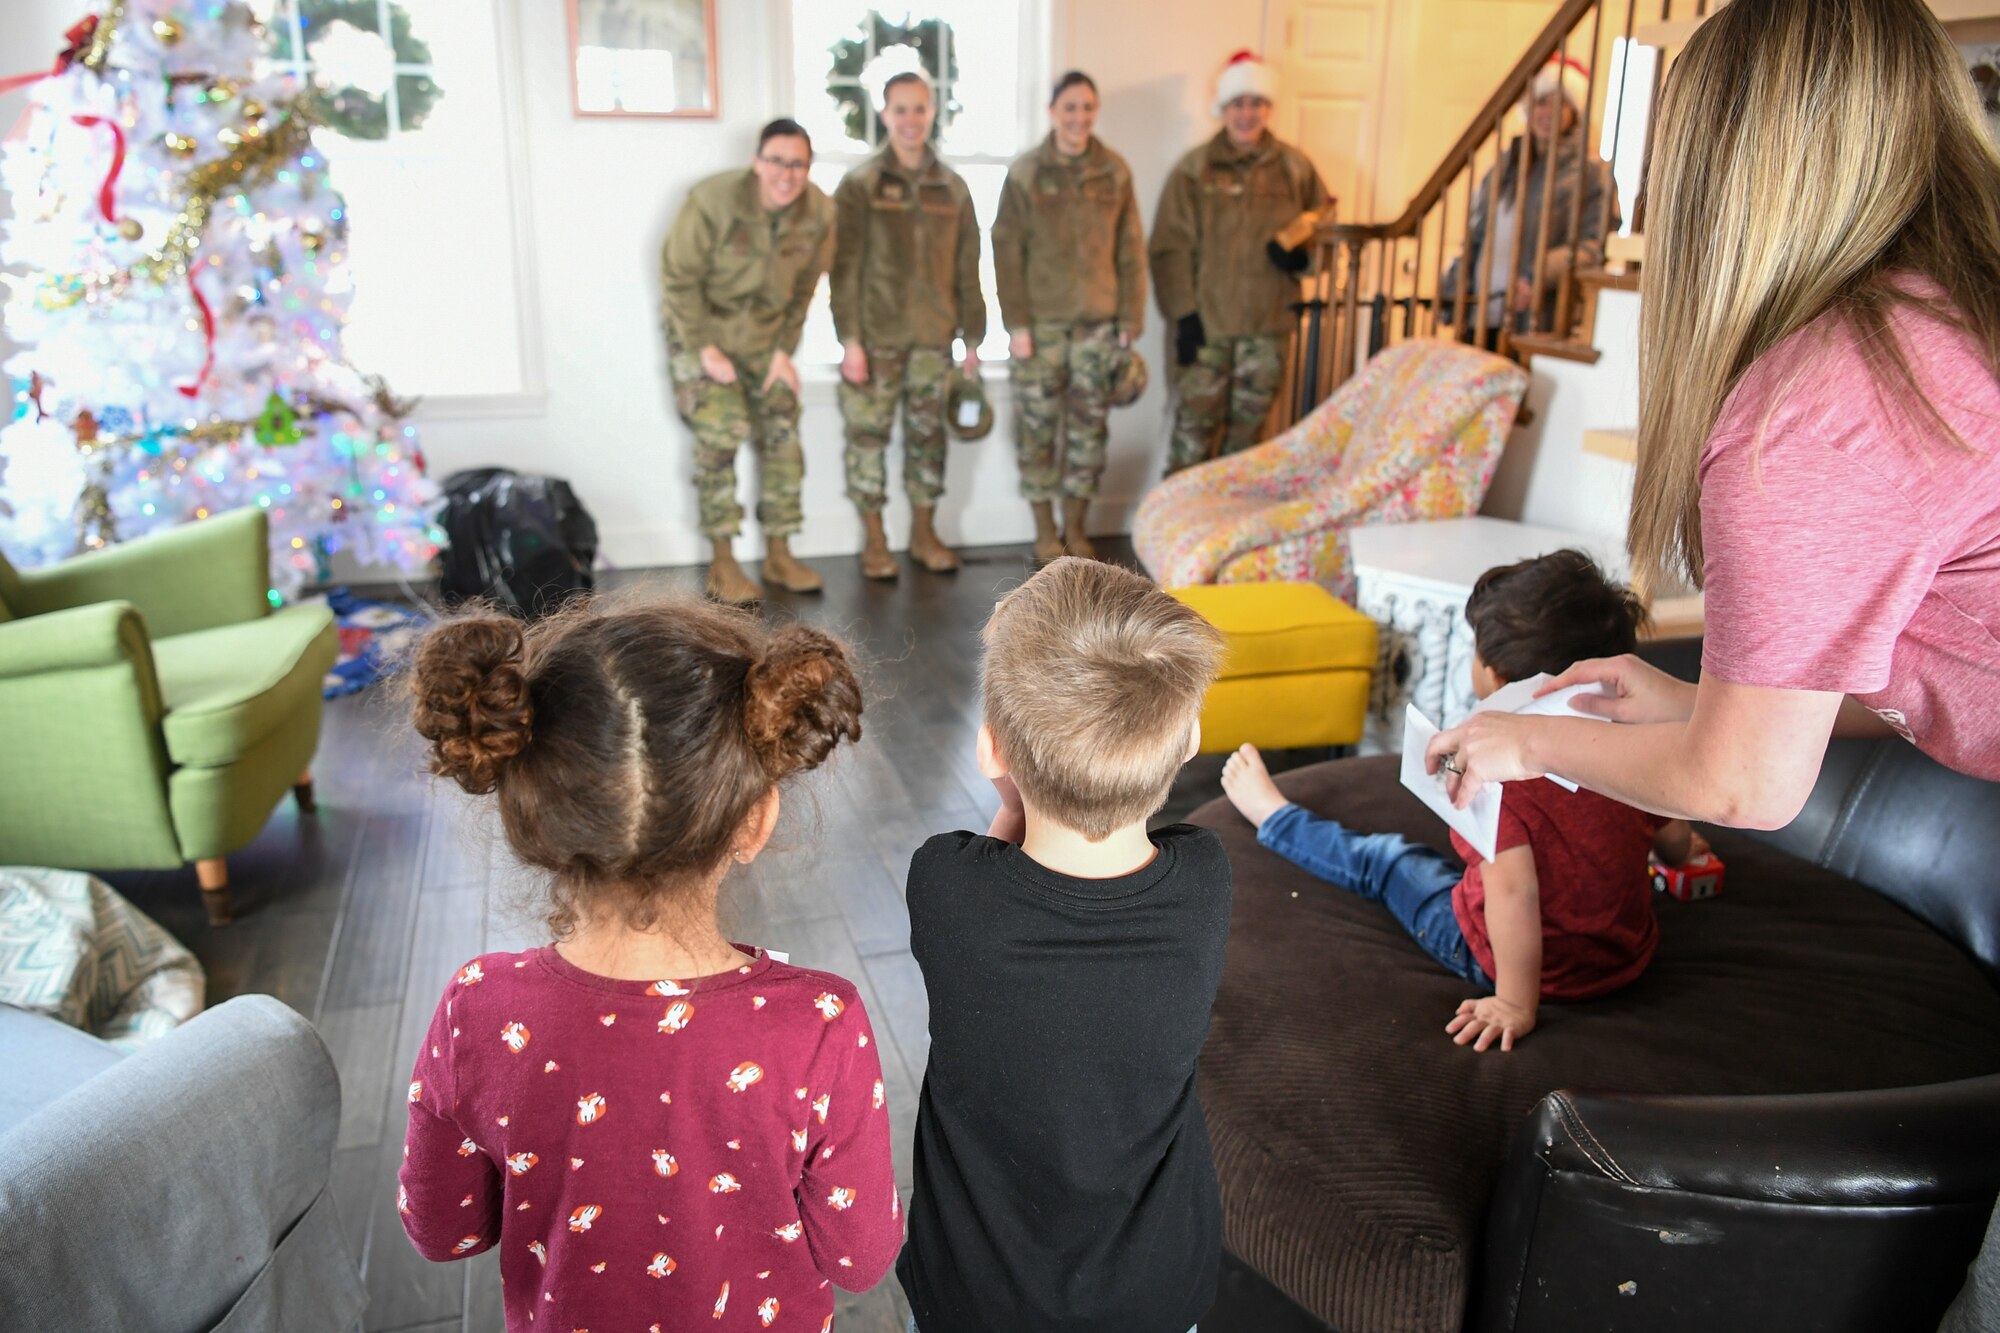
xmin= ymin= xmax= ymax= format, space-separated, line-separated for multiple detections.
xmin=412 ymin=614 xmax=534 ymax=797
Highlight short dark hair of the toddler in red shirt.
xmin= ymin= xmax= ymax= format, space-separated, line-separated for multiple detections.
xmin=1466 ymin=550 xmax=1646 ymax=681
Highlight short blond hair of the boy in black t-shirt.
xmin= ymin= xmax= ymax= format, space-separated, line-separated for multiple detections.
xmin=980 ymin=556 xmax=1222 ymax=841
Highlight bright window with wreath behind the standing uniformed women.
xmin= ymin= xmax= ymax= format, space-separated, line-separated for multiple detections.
xmin=792 ymin=0 xmax=1046 ymax=364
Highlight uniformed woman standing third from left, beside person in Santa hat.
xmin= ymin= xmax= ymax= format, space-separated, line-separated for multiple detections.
xmin=994 ymin=72 xmax=1146 ymax=560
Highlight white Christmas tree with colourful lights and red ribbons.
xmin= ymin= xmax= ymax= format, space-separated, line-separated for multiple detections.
xmin=0 ymin=0 xmax=442 ymax=600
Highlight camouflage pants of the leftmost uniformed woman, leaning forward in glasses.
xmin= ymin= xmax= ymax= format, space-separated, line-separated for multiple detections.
xmin=666 ymin=344 xmax=806 ymax=538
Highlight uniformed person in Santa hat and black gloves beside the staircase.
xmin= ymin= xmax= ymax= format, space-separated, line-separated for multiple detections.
xmin=1150 ymin=74 xmax=1328 ymax=472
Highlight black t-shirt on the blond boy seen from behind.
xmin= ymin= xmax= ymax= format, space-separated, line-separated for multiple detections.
xmin=896 ymin=825 xmax=1230 ymax=1333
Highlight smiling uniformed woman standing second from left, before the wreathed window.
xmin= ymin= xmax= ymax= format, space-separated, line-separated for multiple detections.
xmin=832 ymin=74 xmax=986 ymax=578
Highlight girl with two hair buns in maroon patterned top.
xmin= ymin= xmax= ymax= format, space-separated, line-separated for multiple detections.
xmin=398 ymin=598 xmax=902 ymax=1333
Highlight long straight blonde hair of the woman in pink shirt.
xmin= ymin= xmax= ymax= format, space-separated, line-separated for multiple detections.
xmin=1630 ymin=0 xmax=2000 ymax=586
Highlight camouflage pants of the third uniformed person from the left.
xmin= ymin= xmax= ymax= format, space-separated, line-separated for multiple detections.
xmin=1010 ymin=320 xmax=1118 ymax=502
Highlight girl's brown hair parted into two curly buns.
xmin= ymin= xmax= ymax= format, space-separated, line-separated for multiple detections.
xmin=410 ymin=594 xmax=862 ymax=937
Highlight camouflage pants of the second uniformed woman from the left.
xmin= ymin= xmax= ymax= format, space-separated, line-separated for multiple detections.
xmin=840 ymin=346 xmax=952 ymax=514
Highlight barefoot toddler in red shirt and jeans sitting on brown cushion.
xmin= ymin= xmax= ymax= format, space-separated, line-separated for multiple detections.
xmin=1222 ymin=550 xmax=1708 ymax=1051
